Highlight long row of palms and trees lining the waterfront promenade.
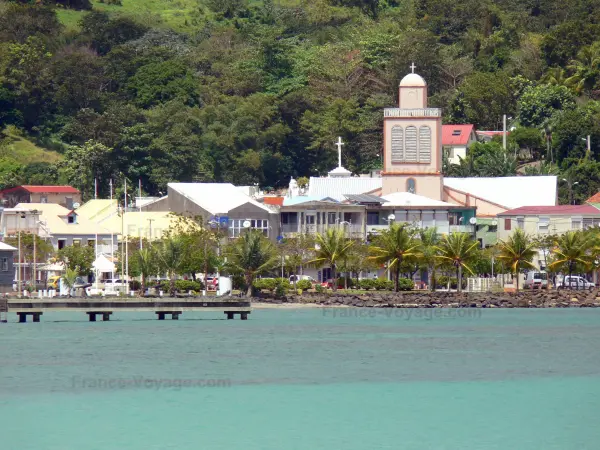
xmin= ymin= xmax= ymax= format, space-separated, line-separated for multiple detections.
xmin=126 ymin=223 xmax=600 ymax=296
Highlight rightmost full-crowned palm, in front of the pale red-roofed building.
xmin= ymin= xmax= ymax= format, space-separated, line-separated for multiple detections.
xmin=548 ymin=231 xmax=594 ymax=284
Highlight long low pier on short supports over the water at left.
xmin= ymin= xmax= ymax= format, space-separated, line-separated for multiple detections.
xmin=0 ymin=297 xmax=252 ymax=323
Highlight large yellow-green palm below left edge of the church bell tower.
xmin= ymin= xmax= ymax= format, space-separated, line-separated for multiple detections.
xmin=370 ymin=223 xmax=419 ymax=292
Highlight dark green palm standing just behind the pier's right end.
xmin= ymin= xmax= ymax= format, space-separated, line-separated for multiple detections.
xmin=226 ymin=229 xmax=279 ymax=297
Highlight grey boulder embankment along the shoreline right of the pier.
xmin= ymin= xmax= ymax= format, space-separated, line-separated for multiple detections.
xmin=251 ymin=290 xmax=600 ymax=308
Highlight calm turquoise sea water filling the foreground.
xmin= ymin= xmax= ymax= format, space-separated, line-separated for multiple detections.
xmin=0 ymin=309 xmax=600 ymax=450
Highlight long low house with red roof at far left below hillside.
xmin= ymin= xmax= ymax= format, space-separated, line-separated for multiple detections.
xmin=0 ymin=185 xmax=81 ymax=209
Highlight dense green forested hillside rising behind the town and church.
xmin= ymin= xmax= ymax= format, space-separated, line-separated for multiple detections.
xmin=0 ymin=0 xmax=600 ymax=202
